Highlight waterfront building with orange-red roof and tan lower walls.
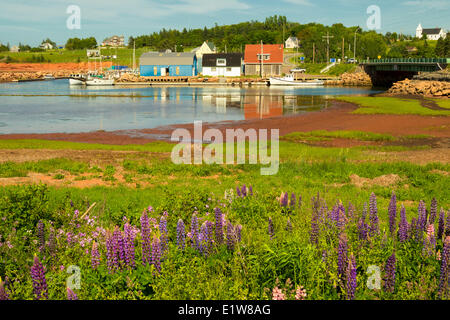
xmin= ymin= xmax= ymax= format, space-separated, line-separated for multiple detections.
xmin=244 ymin=44 xmax=284 ymax=77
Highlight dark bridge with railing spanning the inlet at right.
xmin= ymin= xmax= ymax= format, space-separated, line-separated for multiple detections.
xmin=360 ymin=58 xmax=450 ymax=87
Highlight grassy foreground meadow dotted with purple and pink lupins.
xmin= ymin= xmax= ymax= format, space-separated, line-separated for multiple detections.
xmin=0 ymin=127 xmax=450 ymax=299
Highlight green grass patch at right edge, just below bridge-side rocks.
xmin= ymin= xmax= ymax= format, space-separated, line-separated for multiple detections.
xmin=336 ymin=97 xmax=450 ymax=116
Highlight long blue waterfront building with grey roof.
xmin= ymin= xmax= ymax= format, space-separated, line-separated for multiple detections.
xmin=139 ymin=52 xmax=198 ymax=77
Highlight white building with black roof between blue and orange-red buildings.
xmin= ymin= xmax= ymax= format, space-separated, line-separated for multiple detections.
xmin=202 ymin=53 xmax=242 ymax=77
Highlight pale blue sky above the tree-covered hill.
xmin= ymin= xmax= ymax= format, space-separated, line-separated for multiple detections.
xmin=0 ymin=0 xmax=450 ymax=46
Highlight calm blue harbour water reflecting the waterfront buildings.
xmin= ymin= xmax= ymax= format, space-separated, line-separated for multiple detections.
xmin=0 ymin=80 xmax=379 ymax=134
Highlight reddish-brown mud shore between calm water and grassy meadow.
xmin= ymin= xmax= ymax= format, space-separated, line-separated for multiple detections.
xmin=0 ymin=100 xmax=450 ymax=145
